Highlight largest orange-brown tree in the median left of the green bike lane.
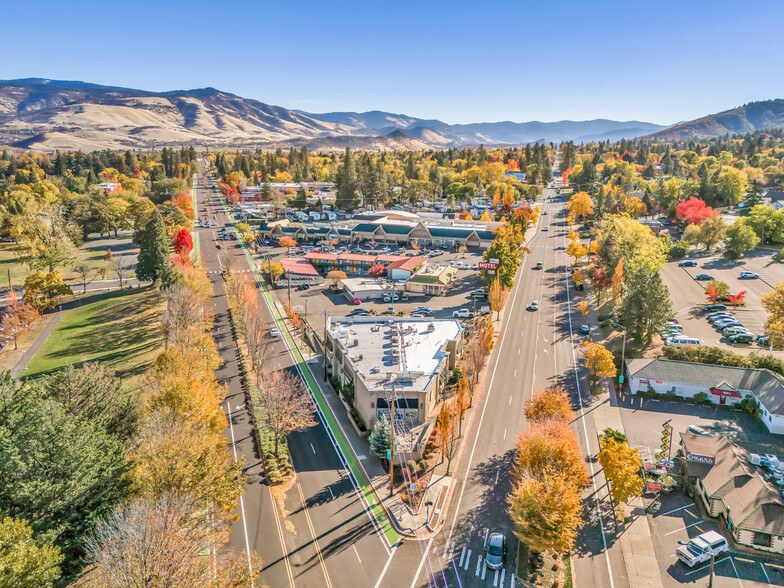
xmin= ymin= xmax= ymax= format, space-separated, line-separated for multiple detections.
xmin=256 ymin=370 xmax=316 ymax=455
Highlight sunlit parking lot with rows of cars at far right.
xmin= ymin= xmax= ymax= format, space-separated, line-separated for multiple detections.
xmin=662 ymin=251 xmax=784 ymax=354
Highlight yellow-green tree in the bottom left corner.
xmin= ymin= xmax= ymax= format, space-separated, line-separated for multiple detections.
xmin=0 ymin=516 xmax=63 ymax=588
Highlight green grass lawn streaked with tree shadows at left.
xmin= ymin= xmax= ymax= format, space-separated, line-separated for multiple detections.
xmin=24 ymin=287 xmax=163 ymax=386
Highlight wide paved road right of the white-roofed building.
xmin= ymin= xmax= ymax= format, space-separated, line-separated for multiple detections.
xmin=418 ymin=179 xmax=627 ymax=587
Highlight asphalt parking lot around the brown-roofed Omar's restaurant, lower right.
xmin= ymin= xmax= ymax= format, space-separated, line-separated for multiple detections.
xmin=620 ymin=396 xmax=784 ymax=588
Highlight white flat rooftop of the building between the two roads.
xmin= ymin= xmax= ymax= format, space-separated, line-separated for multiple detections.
xmin=327 ymin=317 xmax=463 ymax=392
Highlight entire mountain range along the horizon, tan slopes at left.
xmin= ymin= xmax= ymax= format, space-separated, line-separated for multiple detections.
xmin=0 ymin=78 xmax=784 ymax=151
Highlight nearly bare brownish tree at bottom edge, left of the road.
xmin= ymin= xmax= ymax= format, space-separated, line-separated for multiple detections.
xmin=75 ymin=493 xmax=261 ymax=588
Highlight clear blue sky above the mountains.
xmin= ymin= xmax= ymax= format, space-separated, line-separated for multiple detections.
xmin=6 ymin=0 xmax=784 ymax=123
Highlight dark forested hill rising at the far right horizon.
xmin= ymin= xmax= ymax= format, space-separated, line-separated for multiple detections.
xmin=650 ymin=99 xmax=784 ymax=141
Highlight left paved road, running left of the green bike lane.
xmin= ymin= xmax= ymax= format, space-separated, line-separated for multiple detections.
xmin=196 ymin=170 xmax=434 ymax=588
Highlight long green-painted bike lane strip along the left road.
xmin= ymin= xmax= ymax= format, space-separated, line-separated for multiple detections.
xmin=224 ymin=198 xmax=400 ymax=547
